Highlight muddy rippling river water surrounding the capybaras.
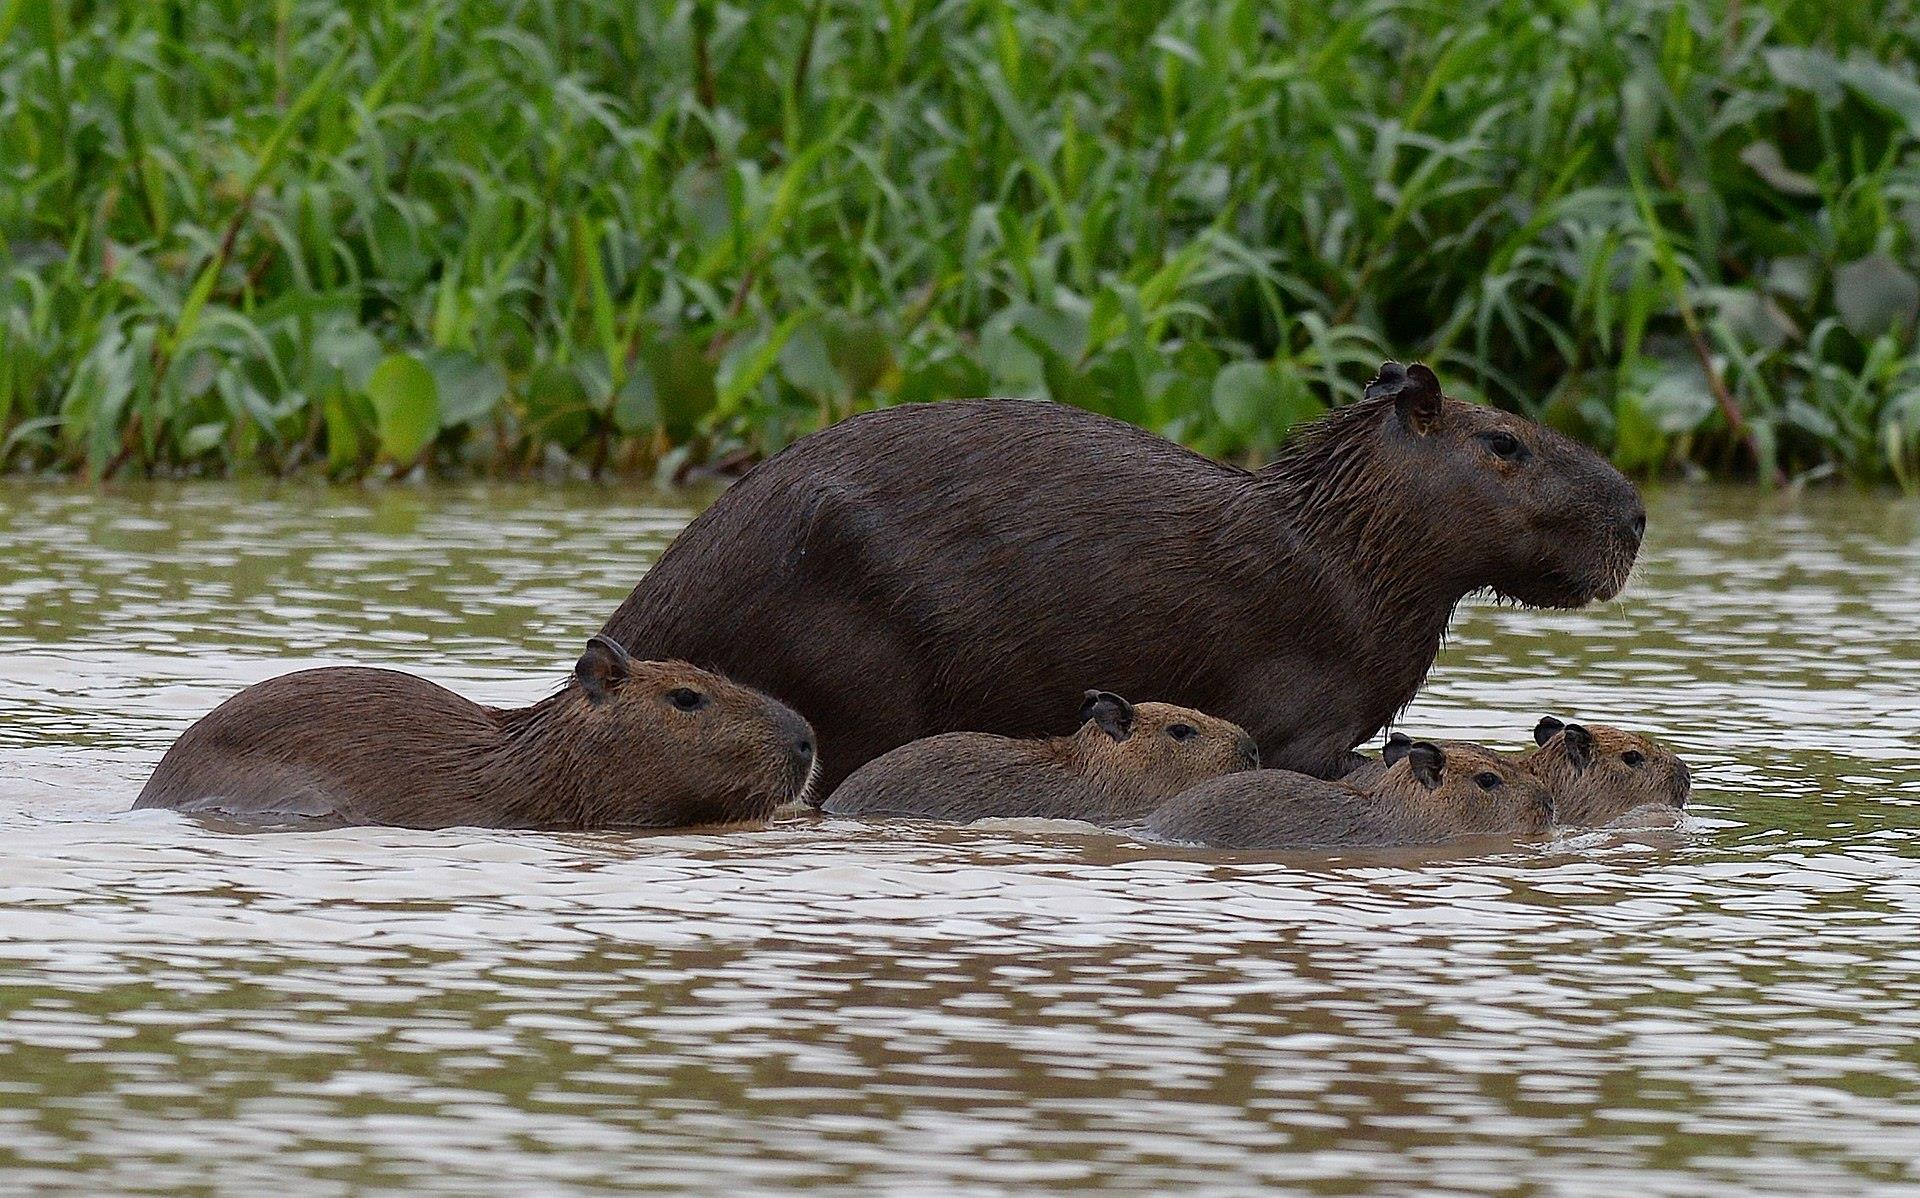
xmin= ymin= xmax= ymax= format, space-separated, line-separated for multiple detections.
xmin=0 ymin=484 xmax=1920 ymax=1198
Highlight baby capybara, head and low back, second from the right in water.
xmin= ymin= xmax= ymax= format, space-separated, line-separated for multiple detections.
xmin=1146 ymin=741 xmax=1553 ymax=849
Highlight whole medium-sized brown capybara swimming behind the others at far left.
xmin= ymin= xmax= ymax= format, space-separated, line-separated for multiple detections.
xmin=134 ymin=637 xmax=814 ymax=829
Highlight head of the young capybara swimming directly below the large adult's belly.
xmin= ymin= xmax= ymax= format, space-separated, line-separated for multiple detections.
xmin=1073 ymin=691 xmax=1260 ymax=799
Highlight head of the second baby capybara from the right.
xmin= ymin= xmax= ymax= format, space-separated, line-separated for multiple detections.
xmin=1371 ymin=739 xmax=1553 ymax=835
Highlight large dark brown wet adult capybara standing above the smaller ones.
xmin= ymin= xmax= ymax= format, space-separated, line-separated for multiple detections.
xmin=605 ymin=363 xmax=1645 ymax=789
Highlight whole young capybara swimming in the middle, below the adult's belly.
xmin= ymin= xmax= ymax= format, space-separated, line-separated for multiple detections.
xmin=826 ymin=691 xmax=1260 ymax=824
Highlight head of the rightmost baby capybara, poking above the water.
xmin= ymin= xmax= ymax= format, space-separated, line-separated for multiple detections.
xmin=1526 ymin=716 xmax=1693 ymax=827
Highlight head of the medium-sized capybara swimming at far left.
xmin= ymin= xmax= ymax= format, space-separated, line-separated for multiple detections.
xmin=574 ymin=635 xmax=816 ymax=826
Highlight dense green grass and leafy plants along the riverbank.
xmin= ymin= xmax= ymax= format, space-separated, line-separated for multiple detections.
xmin=0 ymin=0 xmax=1920 ymax=488
